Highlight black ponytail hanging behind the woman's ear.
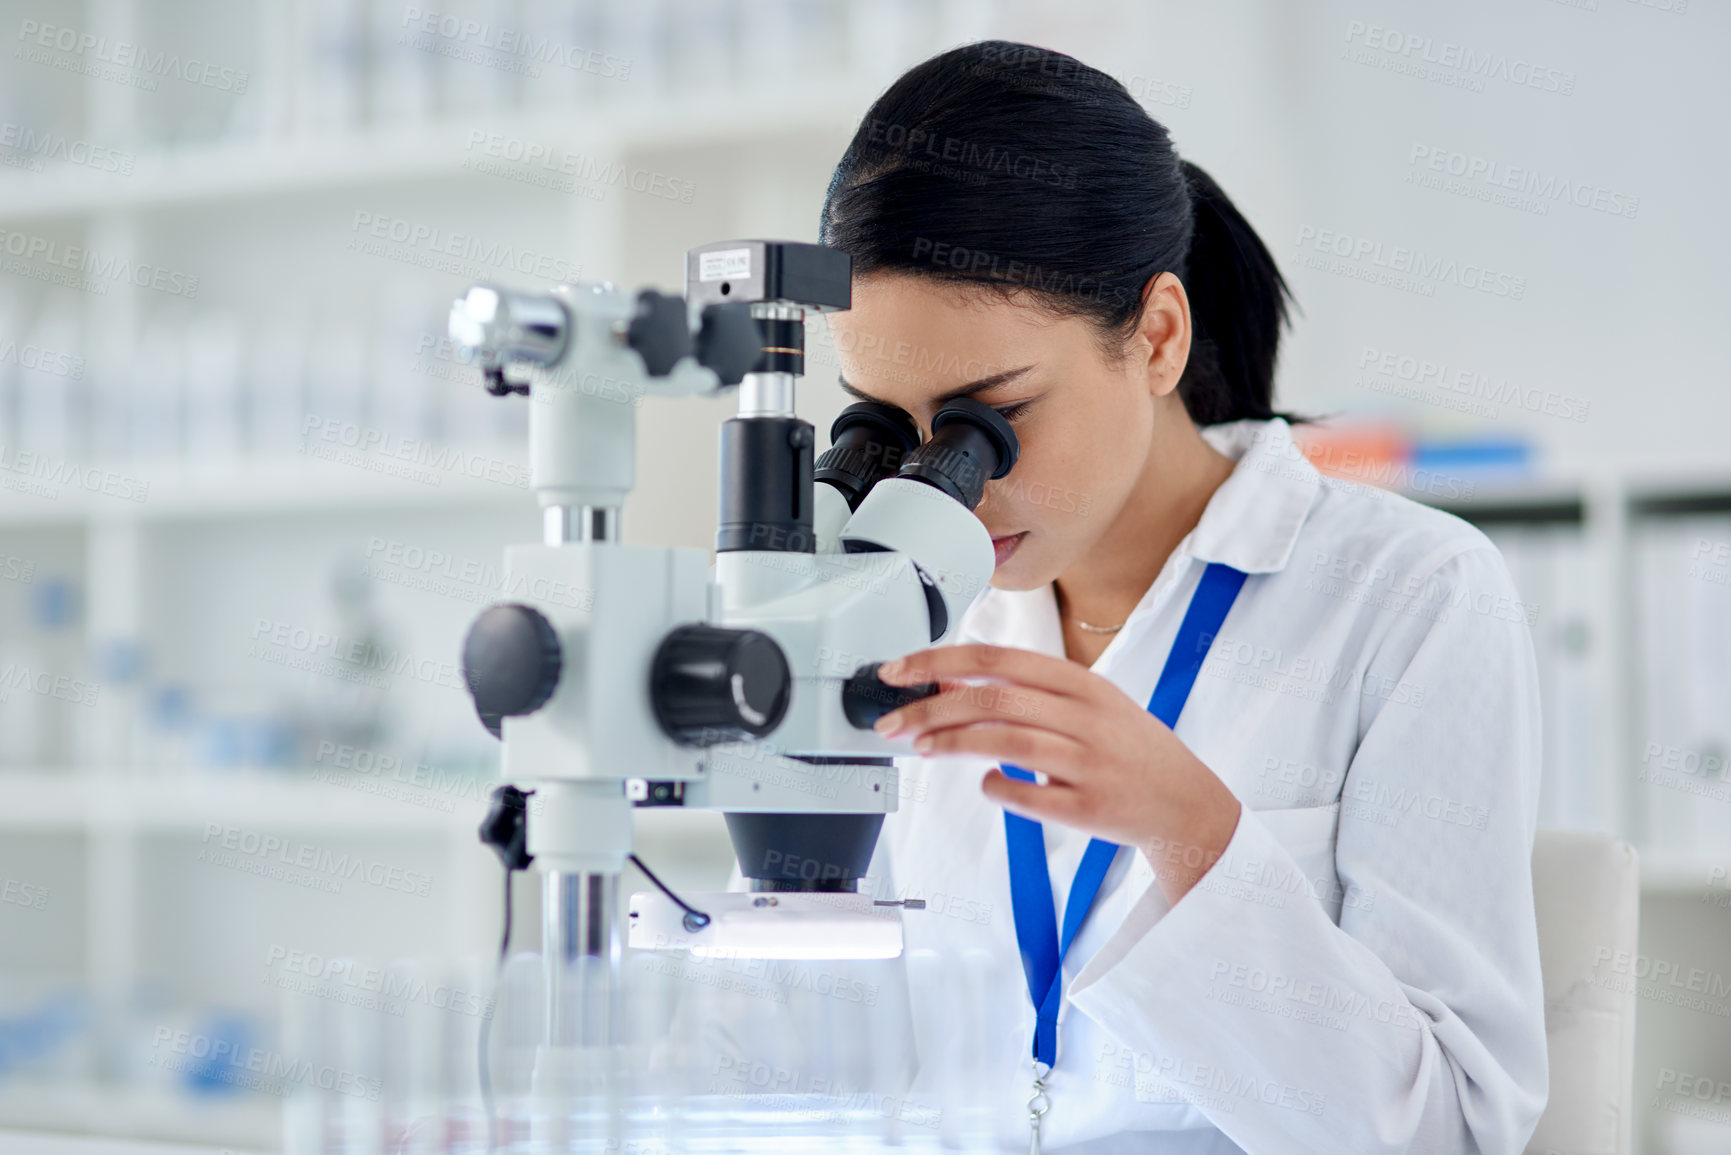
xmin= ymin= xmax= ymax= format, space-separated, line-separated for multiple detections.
xmin=1179 ymin=161 xmax=1291 ymax=424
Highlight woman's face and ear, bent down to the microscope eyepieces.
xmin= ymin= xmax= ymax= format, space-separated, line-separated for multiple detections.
xmin=829 ymin=274 xmax=1189 ymax=589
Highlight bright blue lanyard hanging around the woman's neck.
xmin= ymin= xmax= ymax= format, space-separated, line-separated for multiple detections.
xmin=1002 ymin=561 xmax=1245 ymax=1067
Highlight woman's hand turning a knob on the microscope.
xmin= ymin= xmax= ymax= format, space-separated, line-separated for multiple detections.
xmin=876 ymin=646 xmax=1239 ymax=904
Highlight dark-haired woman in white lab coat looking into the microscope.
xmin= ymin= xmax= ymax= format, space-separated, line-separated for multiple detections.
xmin=822 ymin=42 xmax=1548 ymax=1155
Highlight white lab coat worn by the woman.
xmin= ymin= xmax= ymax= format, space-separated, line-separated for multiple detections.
xmin=862 ymin=419 xmax=1548 ymax=1155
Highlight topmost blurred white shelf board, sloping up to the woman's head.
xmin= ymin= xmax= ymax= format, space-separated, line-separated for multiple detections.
xmin=0 ymin=76 xmax=881 ymax=220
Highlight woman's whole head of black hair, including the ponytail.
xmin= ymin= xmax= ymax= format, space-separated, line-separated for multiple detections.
xmin=820 ymin=40 xmax=1291 ymax=424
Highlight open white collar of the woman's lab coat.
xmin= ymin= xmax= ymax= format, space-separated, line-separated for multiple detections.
xmin=959 ymin=417 xmax=1322 ymax=656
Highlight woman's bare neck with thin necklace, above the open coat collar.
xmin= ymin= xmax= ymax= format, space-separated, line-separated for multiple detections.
xmin=1054 ymin=410 xmax=1238 ymax=665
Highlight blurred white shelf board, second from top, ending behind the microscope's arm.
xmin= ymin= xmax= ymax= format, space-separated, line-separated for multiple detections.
xmin=0 ymin=443 xmax=535 ymax=526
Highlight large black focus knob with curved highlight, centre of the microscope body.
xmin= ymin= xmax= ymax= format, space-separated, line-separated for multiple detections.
xmin=649 ymin=625 xmax=793 ymax=746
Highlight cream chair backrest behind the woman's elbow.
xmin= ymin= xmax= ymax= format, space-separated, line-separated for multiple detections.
xmin=1527 ymin=829 xmax=1641 ymax=1155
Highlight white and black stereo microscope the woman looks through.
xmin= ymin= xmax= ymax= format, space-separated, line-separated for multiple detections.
xmin=450 ymin=241 xmax=1018 ymax=1046
